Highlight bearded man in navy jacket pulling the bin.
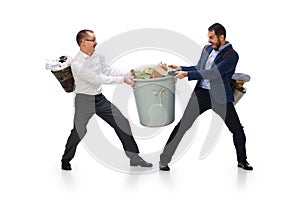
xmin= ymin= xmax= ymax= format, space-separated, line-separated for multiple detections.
xmin=159 ymin=23 xmax=253 ymax=171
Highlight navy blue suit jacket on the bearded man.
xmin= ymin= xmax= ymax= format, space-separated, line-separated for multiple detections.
xmin=181 ymin=44 xmax=239 ymax=104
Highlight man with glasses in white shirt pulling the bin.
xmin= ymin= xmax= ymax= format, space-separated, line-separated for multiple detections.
xmin=61 ymin=29 xmax=153 ymax=170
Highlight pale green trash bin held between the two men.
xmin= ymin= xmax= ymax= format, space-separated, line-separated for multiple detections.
xmin=133 ymin=76 xmax=176 ymax=127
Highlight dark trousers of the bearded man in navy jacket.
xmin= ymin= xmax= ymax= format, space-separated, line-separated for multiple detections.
xmin=160 ymin=88 xmax=247 ymax=164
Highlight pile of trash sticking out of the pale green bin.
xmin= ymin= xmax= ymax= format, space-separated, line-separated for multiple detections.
xmin=130 ymin=62 xmax=168 ymax=79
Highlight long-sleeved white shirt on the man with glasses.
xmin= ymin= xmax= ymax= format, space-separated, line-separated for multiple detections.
xmin=71 ymin=51 xmax=125 ymax=95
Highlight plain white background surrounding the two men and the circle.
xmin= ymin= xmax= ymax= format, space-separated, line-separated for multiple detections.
xmin=0 ymin=0 xmax=300 ymax=200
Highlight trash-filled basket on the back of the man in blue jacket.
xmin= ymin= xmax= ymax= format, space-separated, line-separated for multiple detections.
xmin=231 ymin=73 xmax=251 ymax=104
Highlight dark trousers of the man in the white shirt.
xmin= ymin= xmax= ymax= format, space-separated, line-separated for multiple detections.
xmin=62 ymin=94 xmax=139 ymax=162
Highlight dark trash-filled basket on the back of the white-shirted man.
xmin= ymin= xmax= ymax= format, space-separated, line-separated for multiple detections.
xmin=46 ymin=56 xmax=75 ymax=92
